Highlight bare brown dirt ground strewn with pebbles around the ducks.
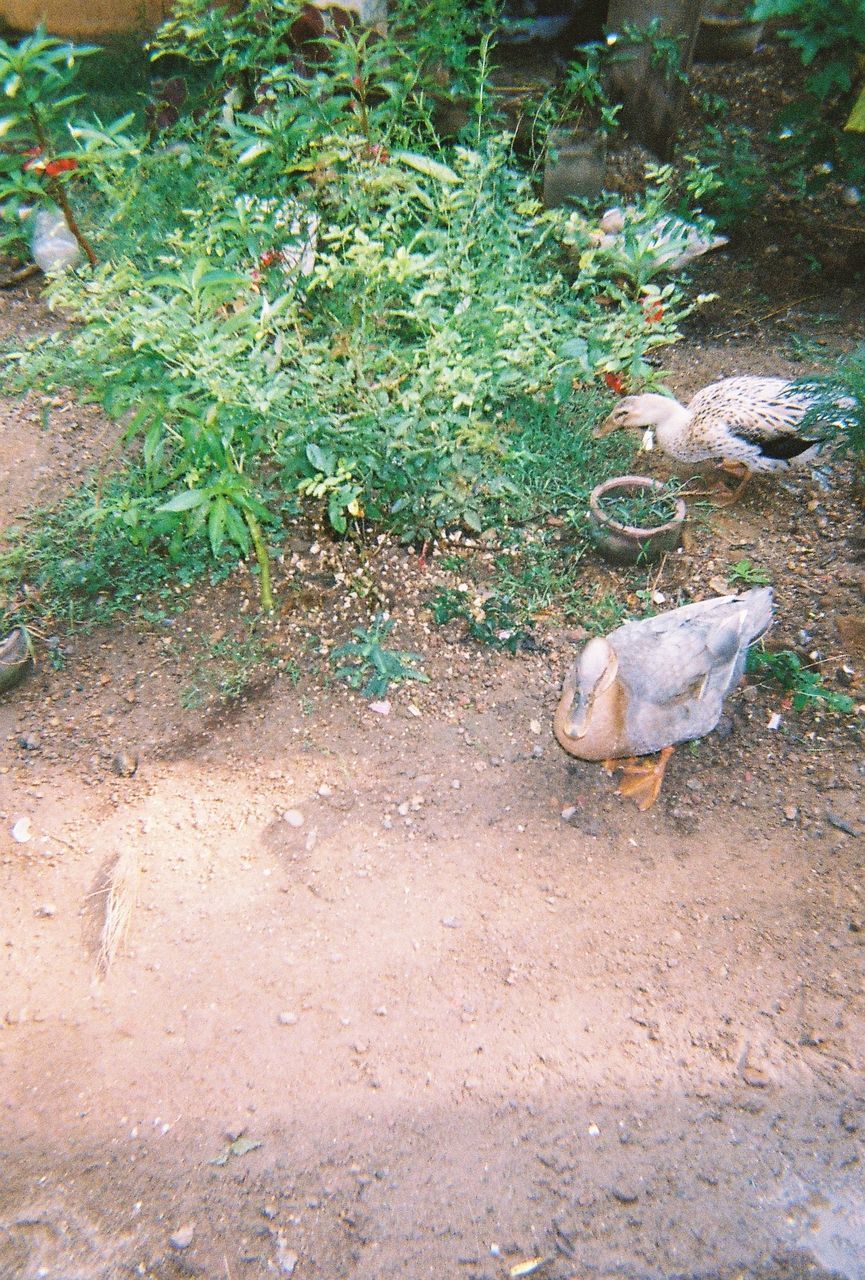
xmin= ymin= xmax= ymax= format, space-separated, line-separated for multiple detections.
xmin=0 ymin=60 xmax=865 ymax=1280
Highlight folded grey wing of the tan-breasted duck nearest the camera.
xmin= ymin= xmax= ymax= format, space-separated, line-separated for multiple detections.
xmin=608 ymin=588 xmax=772 ymax=755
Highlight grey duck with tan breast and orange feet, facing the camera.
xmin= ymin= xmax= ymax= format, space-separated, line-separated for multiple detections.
xmin=553 ymin=586 xmax=772 ymax=809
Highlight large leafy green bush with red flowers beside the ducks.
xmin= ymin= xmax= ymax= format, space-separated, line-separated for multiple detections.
xmin=3 ymin=0 xmax=721 ymax=608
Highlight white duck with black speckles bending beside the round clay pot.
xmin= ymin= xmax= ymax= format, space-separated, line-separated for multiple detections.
xmin=592 ymin=378 xmax=821 ymax=502
